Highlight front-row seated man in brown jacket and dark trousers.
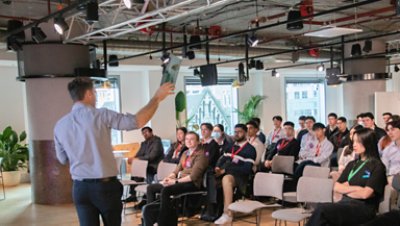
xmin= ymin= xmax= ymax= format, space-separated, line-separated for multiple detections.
xmin=143 ymin=132 xmax=208 ymax=226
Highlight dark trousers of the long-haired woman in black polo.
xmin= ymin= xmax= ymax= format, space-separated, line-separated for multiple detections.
xmin=307 ymin=200 xmax=380 ymax=226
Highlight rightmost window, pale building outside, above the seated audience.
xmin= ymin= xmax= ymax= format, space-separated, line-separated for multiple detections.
xmin=285 ymin=78 xmax=325 ymax=124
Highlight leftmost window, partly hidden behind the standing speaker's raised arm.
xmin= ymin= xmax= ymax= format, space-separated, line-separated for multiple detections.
xmin=94 ymin=77 xmax=122 ymax=144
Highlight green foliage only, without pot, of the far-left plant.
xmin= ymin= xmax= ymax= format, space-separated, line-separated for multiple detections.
xmin=0 ymin=126 xmax=29 ymax=171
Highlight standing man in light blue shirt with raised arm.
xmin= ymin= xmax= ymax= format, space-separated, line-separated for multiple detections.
xmin=54 ymin=78 xmax=174 ymax=226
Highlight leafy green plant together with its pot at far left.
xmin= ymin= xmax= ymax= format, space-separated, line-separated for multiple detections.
xmin=0 ymin=126 xmax=29 ymax=186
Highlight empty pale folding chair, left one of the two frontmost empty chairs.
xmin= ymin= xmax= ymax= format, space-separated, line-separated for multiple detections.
xmin=228 ymin=173 xmax=284 ymax=226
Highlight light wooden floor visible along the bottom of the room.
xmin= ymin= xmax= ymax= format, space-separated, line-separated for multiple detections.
xmin=0 ymin=184 xmax=297 ymax=226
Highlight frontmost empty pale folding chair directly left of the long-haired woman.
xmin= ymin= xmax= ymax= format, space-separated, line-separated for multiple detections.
xmin=272 ymin=177 xmax=333 ymax=226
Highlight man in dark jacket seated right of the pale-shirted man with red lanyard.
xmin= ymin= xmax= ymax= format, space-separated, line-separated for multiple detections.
xmin=329 ymin=117 xmax=349 ymax=167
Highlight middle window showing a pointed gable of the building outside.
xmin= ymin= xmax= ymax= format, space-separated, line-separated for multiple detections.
xmin=185 ymin=77 xmax=238 ymax=134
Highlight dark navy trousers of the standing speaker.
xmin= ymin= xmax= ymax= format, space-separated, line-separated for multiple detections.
xmin=73 ymin=179 xmax=123 ymax=226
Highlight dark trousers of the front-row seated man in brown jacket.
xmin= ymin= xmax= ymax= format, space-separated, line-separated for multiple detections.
xmin=143 ymin=182 xmax=199 ymax=226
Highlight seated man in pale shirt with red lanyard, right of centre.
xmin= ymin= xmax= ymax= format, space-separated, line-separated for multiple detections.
xmin=294 ymin=123 xmax=333 ymax=179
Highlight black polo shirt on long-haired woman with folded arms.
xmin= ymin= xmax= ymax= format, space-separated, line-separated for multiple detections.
xmin=337 ymin=159 xmax=387 ymax=208
